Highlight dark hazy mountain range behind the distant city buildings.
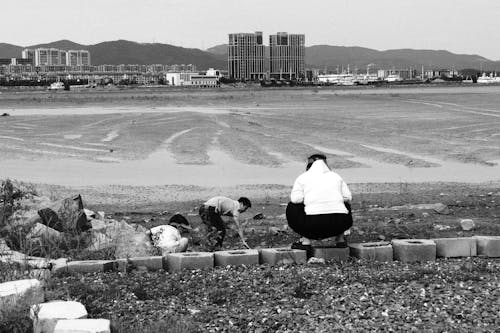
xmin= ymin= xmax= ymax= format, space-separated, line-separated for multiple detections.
xmin=0 ymin=40 xmax=500 ymax=71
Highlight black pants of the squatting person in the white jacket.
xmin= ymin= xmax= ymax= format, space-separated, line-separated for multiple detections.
xmin=286 ymin=202 xmax=352 ymax=239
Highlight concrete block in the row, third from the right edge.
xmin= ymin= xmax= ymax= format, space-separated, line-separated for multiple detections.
xmin=392 ymin=239 xmax=436 ymax=262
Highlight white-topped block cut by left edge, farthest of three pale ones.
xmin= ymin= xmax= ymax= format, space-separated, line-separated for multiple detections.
xmin=0 ymin=279 xmax=45 ymax=310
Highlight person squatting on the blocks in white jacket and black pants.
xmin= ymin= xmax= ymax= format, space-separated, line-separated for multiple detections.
xmin=286 ymin=154 xmax=353 ymax=251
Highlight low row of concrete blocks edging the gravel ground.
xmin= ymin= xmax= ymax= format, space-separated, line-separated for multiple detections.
xmin=1 ymin=236 xmax=494 ymax=274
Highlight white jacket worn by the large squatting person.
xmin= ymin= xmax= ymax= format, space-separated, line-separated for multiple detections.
xmin=290 ymin=160 xmax=352 ymax=215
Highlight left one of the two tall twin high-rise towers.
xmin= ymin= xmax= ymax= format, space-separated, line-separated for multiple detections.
xmin=228 ymin=31 xmax=265 ymax=80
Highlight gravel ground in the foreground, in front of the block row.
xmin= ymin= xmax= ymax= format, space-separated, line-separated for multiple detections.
xmin=44 ymin=258 xmax=500 ymax=332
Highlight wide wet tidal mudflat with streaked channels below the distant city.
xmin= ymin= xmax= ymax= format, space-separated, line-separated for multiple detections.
xmin=0 ymin=86 xmax=500 ymax=197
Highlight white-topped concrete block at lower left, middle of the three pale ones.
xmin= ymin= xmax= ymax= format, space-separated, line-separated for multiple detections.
xmin=30 ymin=301 xmax=88 ymax=333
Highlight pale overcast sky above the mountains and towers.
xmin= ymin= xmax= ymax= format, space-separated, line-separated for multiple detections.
xmin=0 ymin=0 xmax=500 ymax=60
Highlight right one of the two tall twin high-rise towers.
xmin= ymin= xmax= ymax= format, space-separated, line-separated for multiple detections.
xmin=269 ymin=32 xmax=306 ymax=80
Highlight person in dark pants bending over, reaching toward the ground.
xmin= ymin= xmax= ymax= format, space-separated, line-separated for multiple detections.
xmin=199 ymin=196 xmax=252 ymax=251
